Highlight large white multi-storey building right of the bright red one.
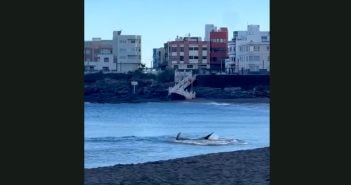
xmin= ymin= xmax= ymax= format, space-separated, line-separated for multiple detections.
xmin=228 ymin=25 xmax=270 ymax=73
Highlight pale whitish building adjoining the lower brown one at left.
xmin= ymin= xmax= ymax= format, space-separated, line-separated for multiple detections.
xmin=112 ymin=31 xmax=141 ymax=73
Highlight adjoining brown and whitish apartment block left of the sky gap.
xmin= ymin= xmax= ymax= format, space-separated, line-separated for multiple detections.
xmin=84 ymin=31 xmax=141 ymax=73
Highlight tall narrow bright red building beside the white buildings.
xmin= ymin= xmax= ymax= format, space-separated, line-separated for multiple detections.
xmin=210 ymin=27 xmax=228 ymax=72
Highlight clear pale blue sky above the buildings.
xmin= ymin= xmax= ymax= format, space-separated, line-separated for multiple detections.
xmin=84 ymin=0 xmax=270 ymax=67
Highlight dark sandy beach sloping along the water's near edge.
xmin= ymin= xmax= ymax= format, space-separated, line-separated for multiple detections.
xmin=84 ymin=147 xmax=270 ymax=185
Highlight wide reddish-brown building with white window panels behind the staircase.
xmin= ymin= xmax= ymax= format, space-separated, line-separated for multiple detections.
xmin=165 ymin=37 xmax=210 ymax=71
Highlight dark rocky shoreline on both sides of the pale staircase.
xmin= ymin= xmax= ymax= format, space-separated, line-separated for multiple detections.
xmin=84 ymin=73 xmax=270 ymax=103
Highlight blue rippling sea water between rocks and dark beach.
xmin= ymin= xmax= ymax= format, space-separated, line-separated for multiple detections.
xmin=84 ymin=101 xmax=269 ymax=168
